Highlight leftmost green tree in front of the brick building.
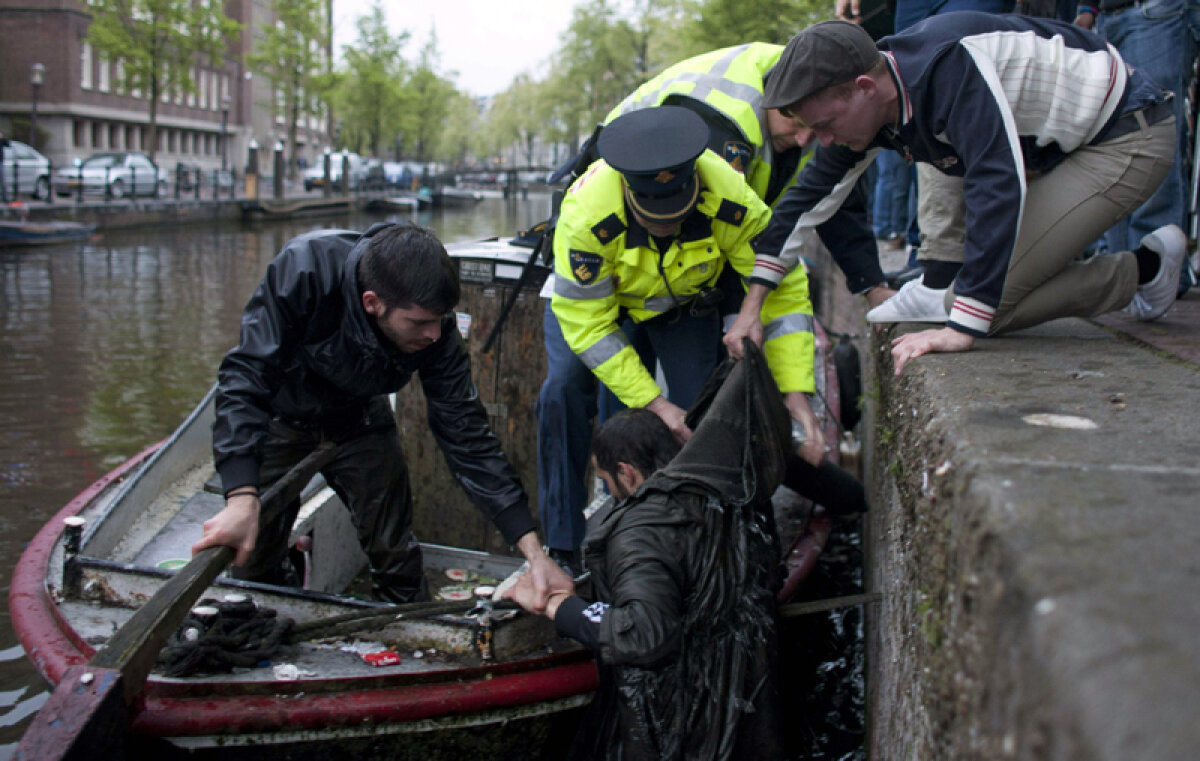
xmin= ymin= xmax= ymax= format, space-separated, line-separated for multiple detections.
xmin=88 ymin=0 xmax=241 ymax=160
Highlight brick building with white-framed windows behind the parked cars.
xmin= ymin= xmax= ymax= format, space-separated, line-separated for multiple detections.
xmin=0 ymin=0 xmax=328 ymax=173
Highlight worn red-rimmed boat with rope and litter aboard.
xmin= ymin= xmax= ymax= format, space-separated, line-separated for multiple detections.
xmin=10 ymin=239 xmax=854 ymax=759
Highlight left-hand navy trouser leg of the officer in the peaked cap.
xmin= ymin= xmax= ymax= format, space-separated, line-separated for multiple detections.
xmin=535 ymin=300 xmax=596 ymax=552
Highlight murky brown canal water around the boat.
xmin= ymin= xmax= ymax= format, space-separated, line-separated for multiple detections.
xmin=0 ymin=193 xmax=862 ymax=761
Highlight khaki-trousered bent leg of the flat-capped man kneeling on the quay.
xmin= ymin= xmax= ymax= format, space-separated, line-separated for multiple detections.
xmin=988 ymin=119 xmax=1175 ymax=335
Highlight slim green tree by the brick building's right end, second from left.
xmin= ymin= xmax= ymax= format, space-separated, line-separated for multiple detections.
xmin=246 ymin=0 xmax=328 ymax=180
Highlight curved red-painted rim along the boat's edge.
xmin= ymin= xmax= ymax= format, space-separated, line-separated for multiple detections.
xmin=8 ymin=442 xmax=596 ymax=737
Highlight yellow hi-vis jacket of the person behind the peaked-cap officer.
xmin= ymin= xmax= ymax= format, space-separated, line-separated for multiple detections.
xmin=604 ymin=42 xmax=812 ymax=206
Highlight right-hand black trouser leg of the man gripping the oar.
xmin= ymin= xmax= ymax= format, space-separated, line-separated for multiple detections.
xmin=322 ymin=397 xmax=430 ymax=603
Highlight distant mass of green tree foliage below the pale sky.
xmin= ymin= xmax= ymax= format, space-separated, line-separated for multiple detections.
xmin=324 ymin=0 xmax=833 ymax=166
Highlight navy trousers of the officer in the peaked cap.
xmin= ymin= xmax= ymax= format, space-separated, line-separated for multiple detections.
xmin=536 ymin=300 xmax=722 ymax=550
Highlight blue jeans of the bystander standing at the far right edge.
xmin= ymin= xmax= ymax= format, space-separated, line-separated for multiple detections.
xmin=1093 ymin=0 xmax=1200 ymax=252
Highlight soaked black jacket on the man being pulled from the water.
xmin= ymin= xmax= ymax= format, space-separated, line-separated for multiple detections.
xmin=554 ymin=346 xmax=791 ymax=761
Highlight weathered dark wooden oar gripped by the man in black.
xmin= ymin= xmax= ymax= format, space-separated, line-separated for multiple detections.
xmin=16 ymin=442 xmax=334 ymax=761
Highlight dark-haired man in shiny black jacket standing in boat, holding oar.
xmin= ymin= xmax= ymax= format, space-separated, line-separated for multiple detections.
xmin=192 ymin=224 xmax=570 ymax=606
